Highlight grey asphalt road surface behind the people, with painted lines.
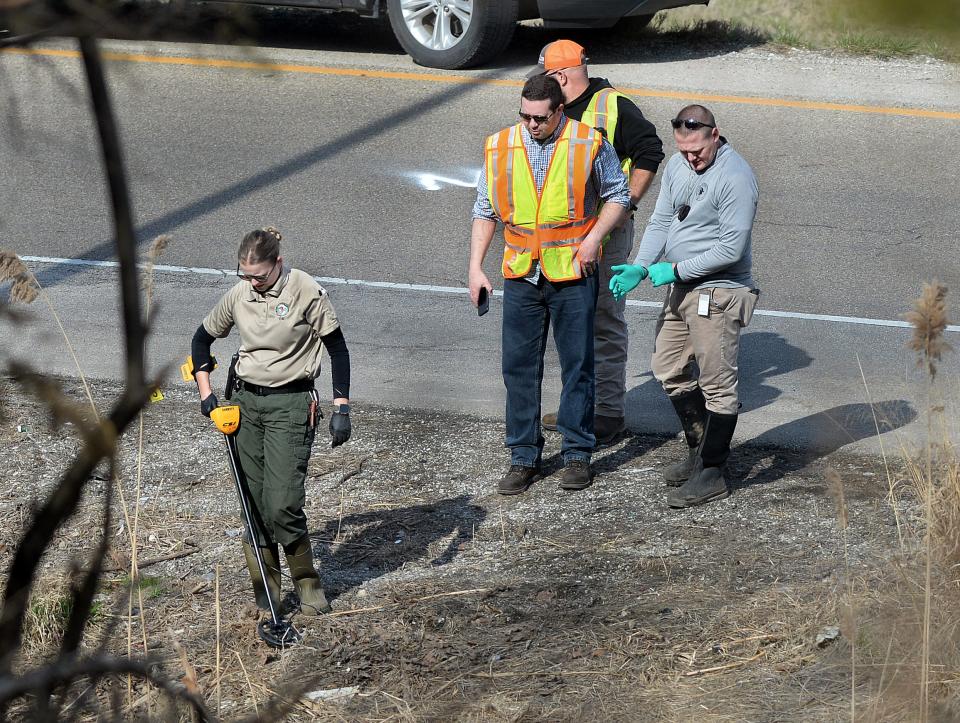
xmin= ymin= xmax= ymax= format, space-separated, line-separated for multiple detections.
xmin=0 ymin=21 xmax=960 ymax=450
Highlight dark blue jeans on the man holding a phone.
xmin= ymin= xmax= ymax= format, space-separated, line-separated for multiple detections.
xmin=503 ymin=275 xmax=598 ymax=467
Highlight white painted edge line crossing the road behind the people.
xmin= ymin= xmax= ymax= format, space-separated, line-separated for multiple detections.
xmin=20 ymin=256 xmax=960 ymax=332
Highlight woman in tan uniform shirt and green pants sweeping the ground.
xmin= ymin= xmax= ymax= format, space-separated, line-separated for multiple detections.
xmin=191 ymin=227 xmax=351 ymax=615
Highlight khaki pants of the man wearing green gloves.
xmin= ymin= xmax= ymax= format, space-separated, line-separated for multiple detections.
xmin=651 ymin=284 xmax=759 ymax=414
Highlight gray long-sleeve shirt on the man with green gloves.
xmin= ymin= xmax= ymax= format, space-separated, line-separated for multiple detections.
xmin=634 ymin=142 xmax=759 ymax=289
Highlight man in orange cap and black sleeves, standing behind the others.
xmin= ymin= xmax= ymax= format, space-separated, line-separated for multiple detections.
xmin=527 ymin=40 xmax=663 ymax=447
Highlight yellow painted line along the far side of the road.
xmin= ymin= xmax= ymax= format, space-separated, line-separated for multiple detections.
xmin=7 ymin=48 xmax=960 ymax=120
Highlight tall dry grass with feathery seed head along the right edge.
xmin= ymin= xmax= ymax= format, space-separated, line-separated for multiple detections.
xmin=841 ymin=282 xmax=960 ymax=721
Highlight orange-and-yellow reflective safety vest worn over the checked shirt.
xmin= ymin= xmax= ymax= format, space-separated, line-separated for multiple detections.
xmin=485 ymin=119 xmax=603 ymax=281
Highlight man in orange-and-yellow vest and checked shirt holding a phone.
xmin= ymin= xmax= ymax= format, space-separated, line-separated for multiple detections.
xmin=469 ymin=75 xmax=630 ymax=494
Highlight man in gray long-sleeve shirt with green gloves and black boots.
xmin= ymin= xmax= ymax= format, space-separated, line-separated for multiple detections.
xmin=610 ymin=105 xmax=759 ymax=507
